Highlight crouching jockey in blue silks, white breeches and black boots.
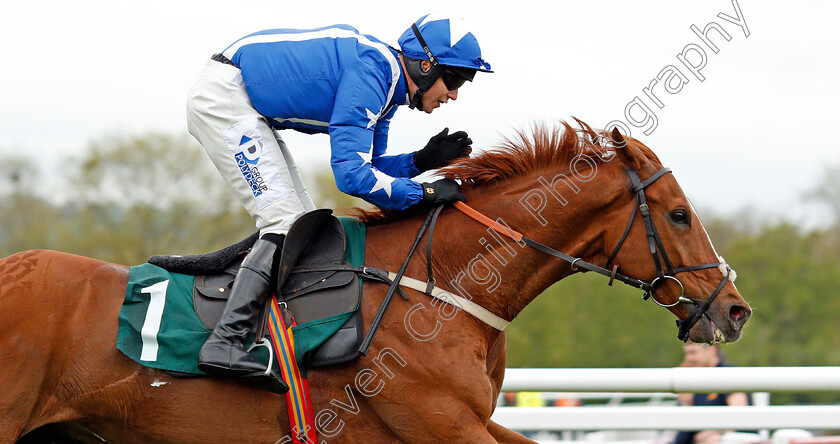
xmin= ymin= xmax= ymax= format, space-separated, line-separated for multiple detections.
xmin=187 ymin=13 xmax=492 ymax=388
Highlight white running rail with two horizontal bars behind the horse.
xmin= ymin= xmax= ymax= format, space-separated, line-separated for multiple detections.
xmin=493 ymin=367 xmax=840 ymax=431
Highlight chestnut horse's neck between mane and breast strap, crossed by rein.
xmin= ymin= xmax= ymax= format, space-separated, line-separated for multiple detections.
xmin=434 ymin=173 xmax=604 ymax=320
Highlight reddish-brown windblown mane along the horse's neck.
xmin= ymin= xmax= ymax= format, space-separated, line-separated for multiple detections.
xmin=347 ymin=118 xmax=660 ymax=224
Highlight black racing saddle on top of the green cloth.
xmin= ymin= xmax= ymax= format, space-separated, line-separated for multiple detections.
xmin=149 ymin=209 xmax=364 ymax=372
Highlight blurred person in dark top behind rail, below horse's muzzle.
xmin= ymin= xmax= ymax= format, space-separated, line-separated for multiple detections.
xmin=674 ymin=344 xmax=750 ymax=444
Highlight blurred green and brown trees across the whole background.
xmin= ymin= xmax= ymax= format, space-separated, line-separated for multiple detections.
xmin=0 ymin=134 xmax=840 ymax=403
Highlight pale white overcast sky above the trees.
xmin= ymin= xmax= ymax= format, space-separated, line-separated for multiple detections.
xmin=0 ymin=0 xmax=840 ymax=225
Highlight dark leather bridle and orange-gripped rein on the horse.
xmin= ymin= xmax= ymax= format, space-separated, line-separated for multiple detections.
xmin=455 ymin=168 xmax=731 ymax=341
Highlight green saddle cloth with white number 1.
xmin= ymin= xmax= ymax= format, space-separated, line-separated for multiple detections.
xmin=117 ymin=217 xmax=365 ymax=375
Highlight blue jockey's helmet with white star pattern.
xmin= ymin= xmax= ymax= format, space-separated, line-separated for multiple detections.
xmin=399 ymin=12 xmax=493 ymax=111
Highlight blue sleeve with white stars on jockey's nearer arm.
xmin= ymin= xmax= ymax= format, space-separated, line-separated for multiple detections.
xmin=329 ymin=63 xmax=423 ymax=210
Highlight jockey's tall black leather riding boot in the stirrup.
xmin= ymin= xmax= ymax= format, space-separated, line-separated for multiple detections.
xmin=198 ymin=239 xmax=289 ymax=393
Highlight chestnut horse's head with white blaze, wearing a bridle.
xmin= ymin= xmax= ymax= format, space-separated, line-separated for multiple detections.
xmin=601 ymin=130 xmax=751 ymax=343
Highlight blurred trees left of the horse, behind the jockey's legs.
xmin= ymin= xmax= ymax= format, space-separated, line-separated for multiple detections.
xmin=0 ymin=134 xmax=365 ymax=265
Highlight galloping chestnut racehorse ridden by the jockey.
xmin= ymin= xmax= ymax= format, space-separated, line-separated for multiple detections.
xmin=0 ymin=122 xmax=750 ymax=444
